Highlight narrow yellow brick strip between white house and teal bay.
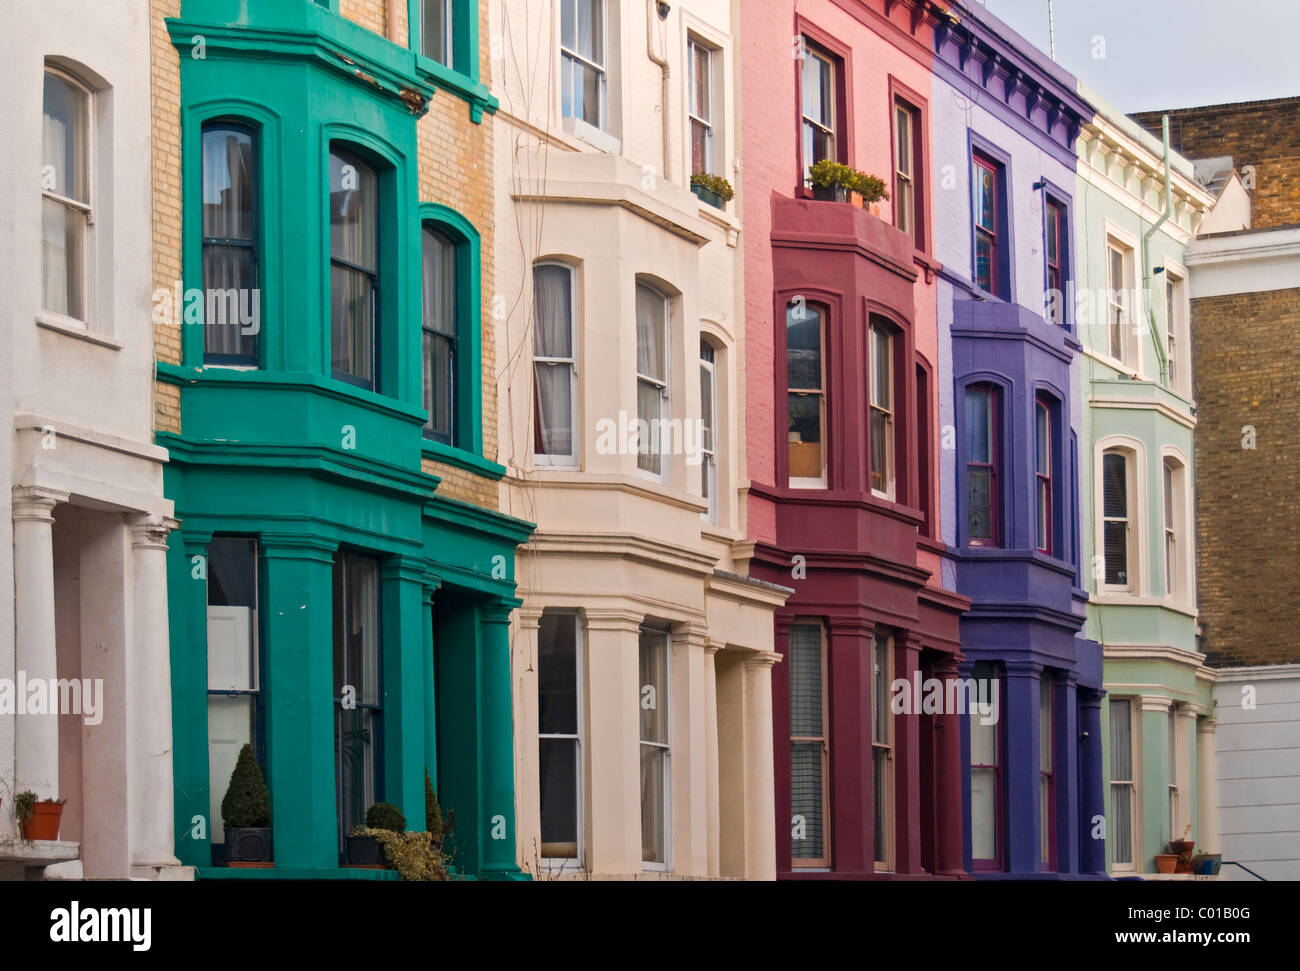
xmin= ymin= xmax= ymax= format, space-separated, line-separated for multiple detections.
xmin=150 ymin=0 xmax=181 ymax=432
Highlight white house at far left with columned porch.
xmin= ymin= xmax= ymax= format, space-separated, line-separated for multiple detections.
xmin=0 ymin=0 xmax=189 ymax=879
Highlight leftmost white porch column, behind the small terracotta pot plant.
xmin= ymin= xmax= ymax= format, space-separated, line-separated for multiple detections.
xmin=13 ymin=486 xmax=68 ymax=799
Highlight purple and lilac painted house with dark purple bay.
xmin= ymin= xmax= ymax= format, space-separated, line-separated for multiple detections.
xmin=932 ymin=3 xmax=1105 ymax=877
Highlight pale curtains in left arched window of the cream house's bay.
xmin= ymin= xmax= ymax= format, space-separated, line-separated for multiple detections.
xmin=533 ymin=265 xmax=573 ymax=455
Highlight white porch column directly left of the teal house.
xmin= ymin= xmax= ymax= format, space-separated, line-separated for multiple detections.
xmin=126 ymin=516 xmax=181 ymax=876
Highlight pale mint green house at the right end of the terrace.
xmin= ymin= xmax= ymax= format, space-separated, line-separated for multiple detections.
xmin=1062 ymin=86 xmax=1217 ymax=876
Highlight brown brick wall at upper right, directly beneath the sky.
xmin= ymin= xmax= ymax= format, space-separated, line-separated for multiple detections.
xmin=1132 ymin=97 xmax=1300 ymax=229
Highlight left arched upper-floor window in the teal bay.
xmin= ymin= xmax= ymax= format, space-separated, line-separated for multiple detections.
xmin=200 ymin=121 xmax=261 ymax=367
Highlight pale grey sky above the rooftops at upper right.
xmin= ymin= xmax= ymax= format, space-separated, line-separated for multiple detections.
xmin=970 ymin=0 xmax=1300 ymax=112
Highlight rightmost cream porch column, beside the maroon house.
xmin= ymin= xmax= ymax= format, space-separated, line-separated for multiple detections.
xmin=745 ymin=651 xmax=781 ymax=880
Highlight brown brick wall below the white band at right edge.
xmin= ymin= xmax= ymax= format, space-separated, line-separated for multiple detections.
xmin=1192 ymin=290 xmax=1300 ymax=666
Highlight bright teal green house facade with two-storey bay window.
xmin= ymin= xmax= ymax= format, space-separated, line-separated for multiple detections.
xmin=157 ymin=0 xmax=533 ymax=879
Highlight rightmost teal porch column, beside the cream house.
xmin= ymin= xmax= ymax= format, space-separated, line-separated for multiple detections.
xmin=478 ymin=601 xmax=523 ymax=880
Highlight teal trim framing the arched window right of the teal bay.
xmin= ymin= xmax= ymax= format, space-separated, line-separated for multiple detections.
xmin=417 ymin=203 xmax=488 ymax=460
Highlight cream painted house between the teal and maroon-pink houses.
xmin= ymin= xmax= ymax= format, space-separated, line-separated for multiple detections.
xmin=491 ymin=0 xmax=790 ymax=879
